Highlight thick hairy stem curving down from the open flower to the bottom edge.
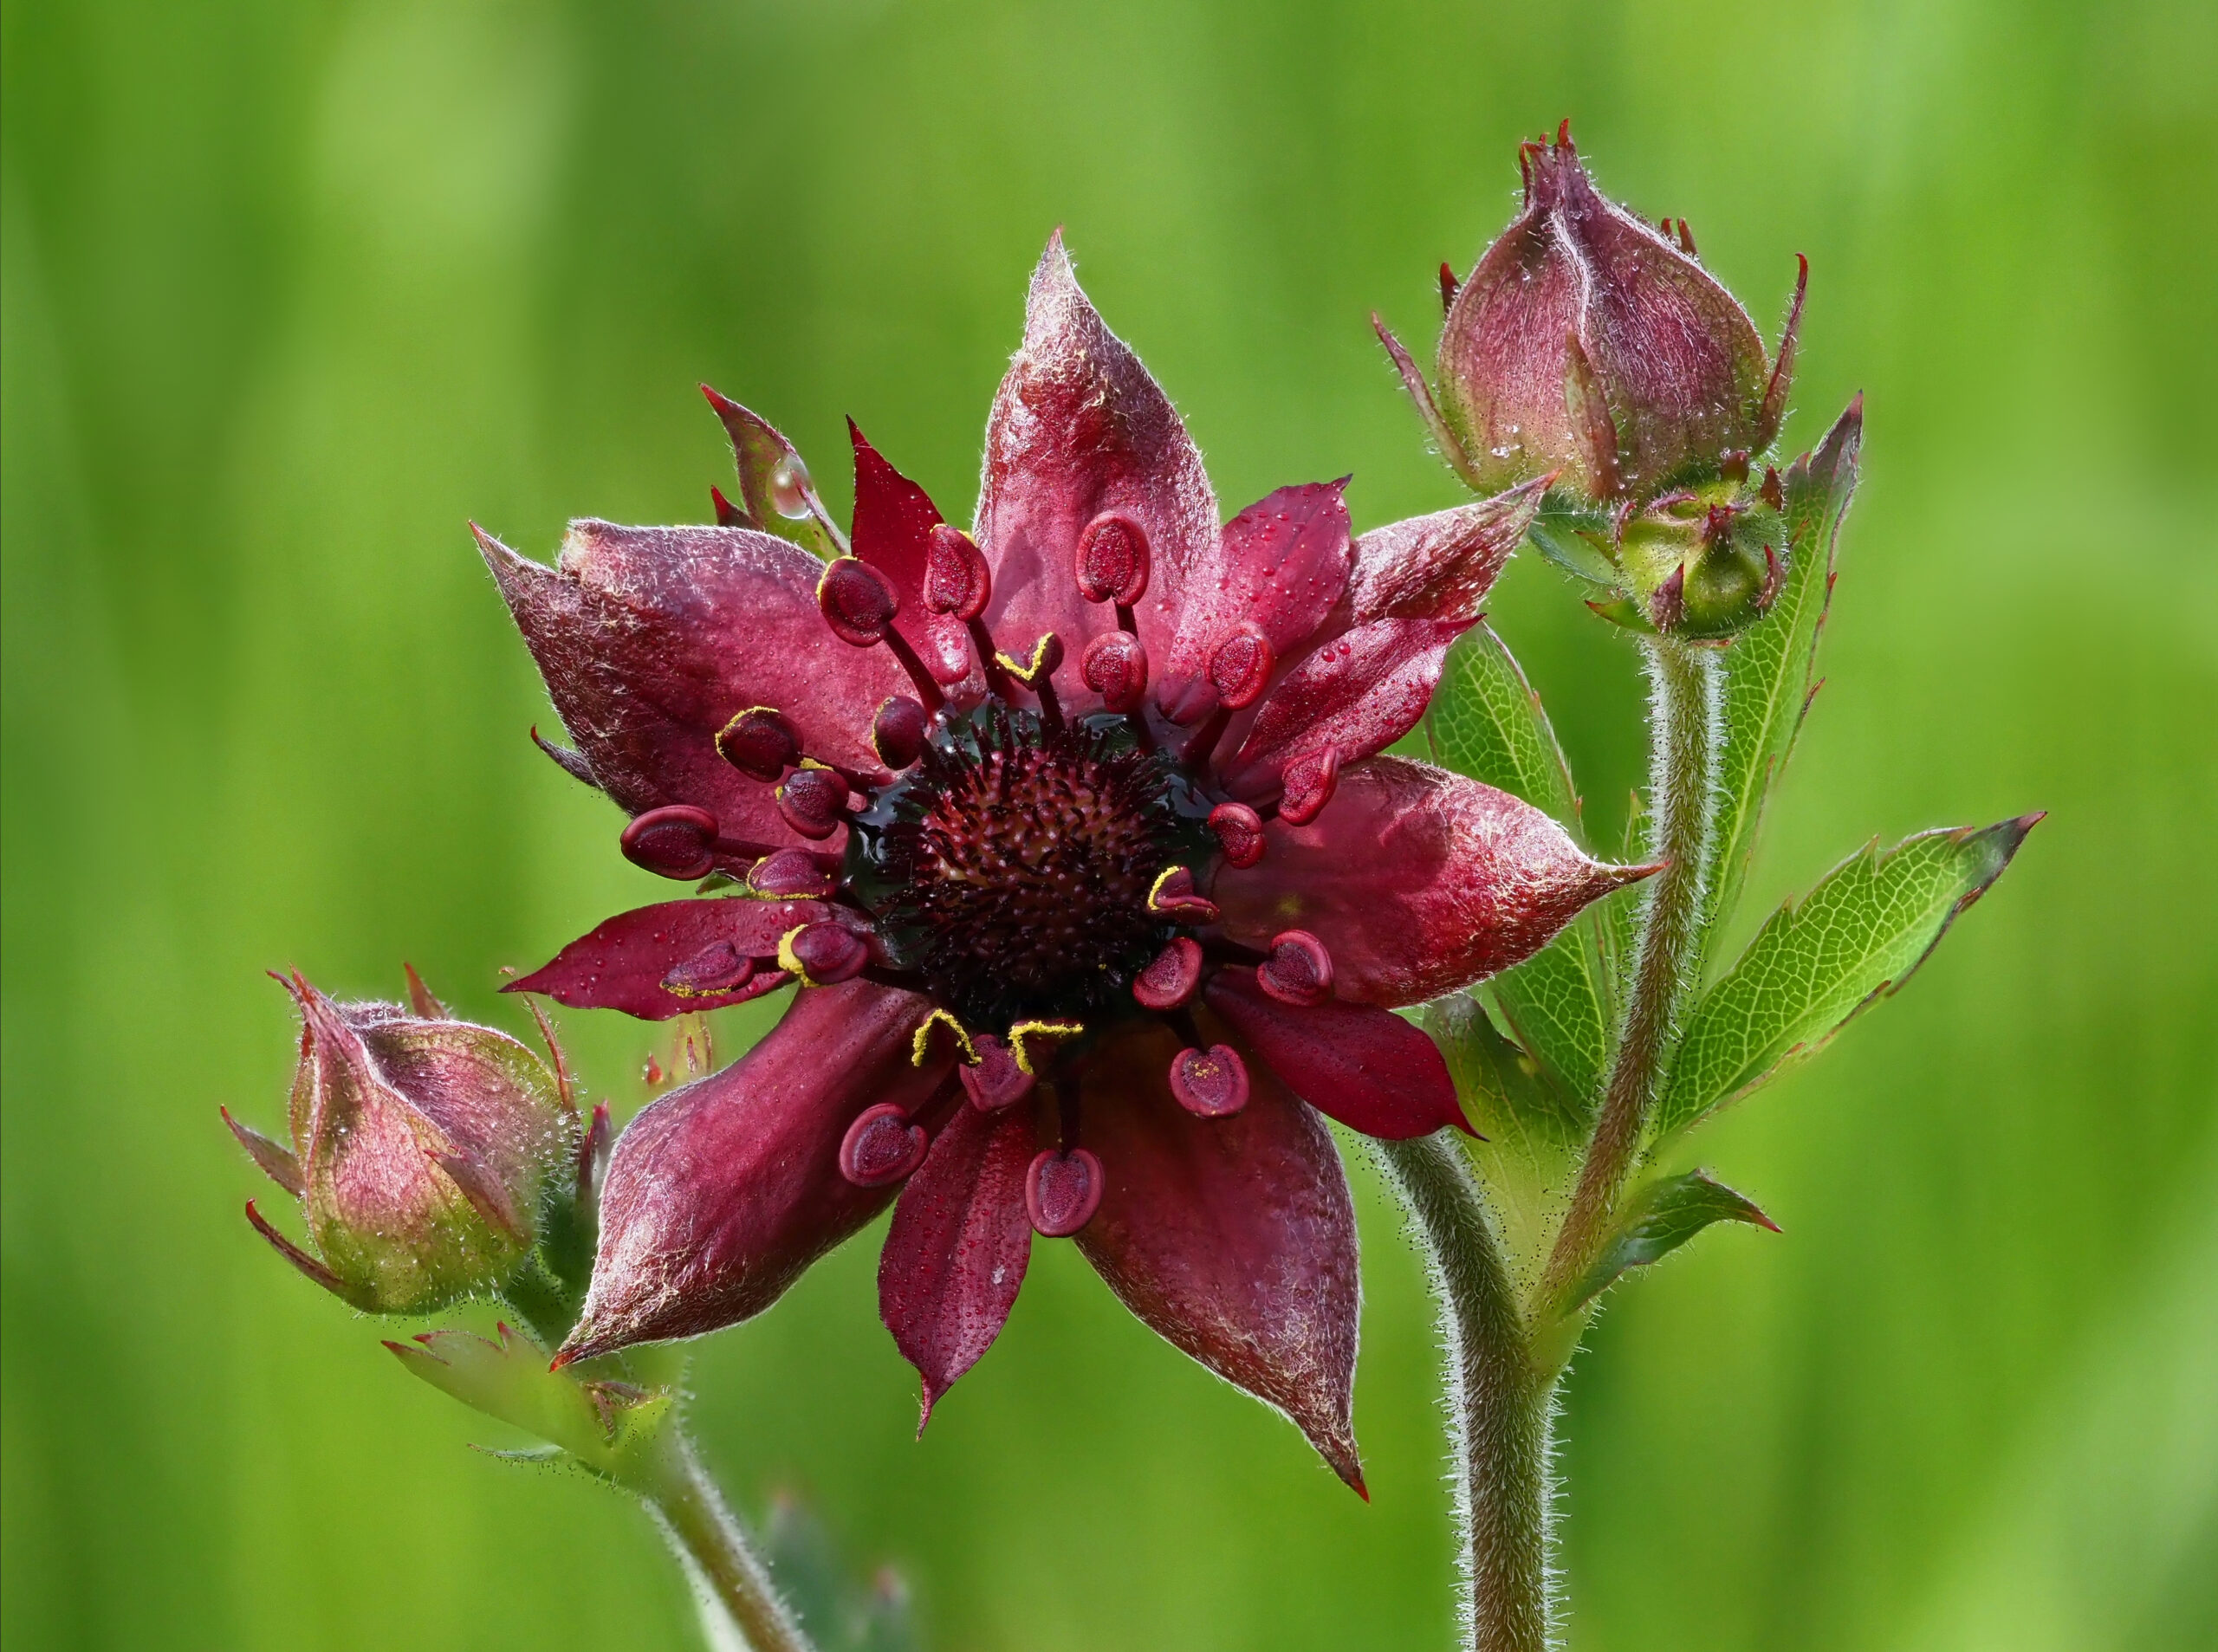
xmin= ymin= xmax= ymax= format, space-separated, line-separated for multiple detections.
xmin=1379 ymin=1133 xmax=1555 ymax=1652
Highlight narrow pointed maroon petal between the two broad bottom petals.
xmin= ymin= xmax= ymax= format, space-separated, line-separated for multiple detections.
xmin=879 ymin=1106 xmax=1031 ymax=1433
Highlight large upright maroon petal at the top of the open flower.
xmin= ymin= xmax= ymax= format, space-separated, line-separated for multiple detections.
xmin=976 ymin=230 xmax=1217 ymax=696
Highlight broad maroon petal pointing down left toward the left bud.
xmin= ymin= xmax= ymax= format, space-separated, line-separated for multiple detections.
xmin=561 ymin=982 xmax=954 ymax=1362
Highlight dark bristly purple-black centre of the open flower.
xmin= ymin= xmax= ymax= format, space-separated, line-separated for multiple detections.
xmin=847 ymin=698 xmax=1213 ymax=1031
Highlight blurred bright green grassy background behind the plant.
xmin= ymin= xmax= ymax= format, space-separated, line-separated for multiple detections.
xmin=0 ymin=0 xmax=2218 ymax=1652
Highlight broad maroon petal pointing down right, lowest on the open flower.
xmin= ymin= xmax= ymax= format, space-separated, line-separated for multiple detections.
xmin=1078 ymin=1025 xmax=1364 ymax=1493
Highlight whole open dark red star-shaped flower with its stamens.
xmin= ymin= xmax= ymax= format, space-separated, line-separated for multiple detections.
xmin=483 ymin=239 xmax=1637 ymax=1488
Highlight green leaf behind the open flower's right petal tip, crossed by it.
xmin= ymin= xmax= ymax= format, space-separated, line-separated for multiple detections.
xmin=1426 ymin=621 xmax=1615 ymax=1105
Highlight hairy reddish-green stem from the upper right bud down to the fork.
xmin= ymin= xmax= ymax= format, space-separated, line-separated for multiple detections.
xmin=1540 ymin=637 xmax=1722 ymax=1302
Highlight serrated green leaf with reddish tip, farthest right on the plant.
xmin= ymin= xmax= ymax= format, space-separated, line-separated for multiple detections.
xmin=1657 ymin=813 xmax=2040 ymax=1136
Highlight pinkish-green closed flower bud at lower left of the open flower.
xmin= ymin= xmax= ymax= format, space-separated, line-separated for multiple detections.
xmin=224 ymin=975 xmax=574 ymax=1312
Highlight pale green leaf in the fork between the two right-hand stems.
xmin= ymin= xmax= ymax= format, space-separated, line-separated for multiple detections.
xmin=1417 ymin=994 xmax=1586 ymax=1288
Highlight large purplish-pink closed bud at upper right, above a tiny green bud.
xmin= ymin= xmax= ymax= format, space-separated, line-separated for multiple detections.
xmin=1439 ymin=122 xmax=1807 ymax=501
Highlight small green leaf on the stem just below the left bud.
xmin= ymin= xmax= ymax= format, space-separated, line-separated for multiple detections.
xmin=386 ymin=1324 xmax=674 ymax=1481
